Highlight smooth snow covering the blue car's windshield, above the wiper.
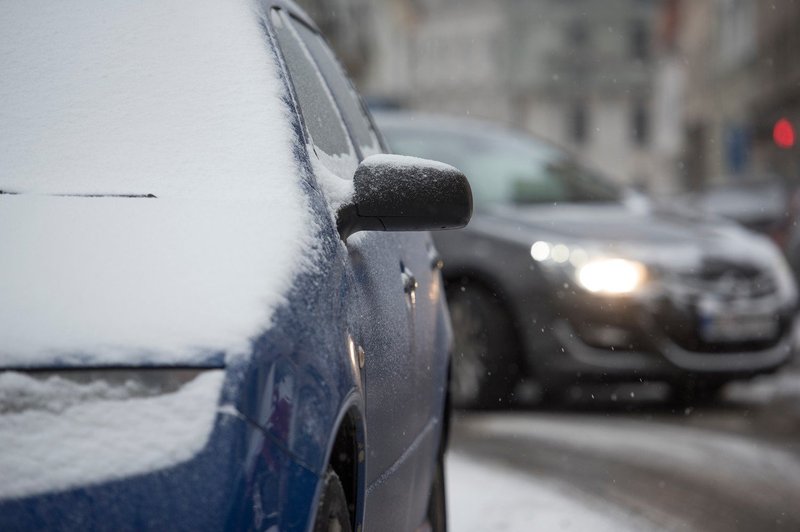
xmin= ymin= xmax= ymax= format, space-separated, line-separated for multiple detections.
xmin=0 ymin=0 xmax=289 ymax=198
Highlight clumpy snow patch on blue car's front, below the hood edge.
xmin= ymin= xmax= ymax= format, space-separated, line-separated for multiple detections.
xmin=0 ymin=370 xmax=224 ymax=499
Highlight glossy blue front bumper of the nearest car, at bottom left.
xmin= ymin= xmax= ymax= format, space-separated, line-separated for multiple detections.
xmin=0 ymin=386 xmax=319 ymax=531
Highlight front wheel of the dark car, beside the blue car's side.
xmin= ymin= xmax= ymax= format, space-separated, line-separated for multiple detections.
xmin=446 ymin=283 xmax=520 ymax=409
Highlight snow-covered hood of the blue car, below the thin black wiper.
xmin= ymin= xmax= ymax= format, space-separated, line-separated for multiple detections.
xmin=0 ymin=195 xmax=313 ymax=368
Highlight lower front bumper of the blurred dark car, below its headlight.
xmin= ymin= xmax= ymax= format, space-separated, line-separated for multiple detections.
xmin=523 ymin=294 xmax=795 ymax=386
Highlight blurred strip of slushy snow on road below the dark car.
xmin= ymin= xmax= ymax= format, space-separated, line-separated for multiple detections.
xmin=460 ymin=414 xmax=800 ymax=500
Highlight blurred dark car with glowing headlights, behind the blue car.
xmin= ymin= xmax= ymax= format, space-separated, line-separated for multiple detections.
xmin=376 ymin=113 xmax=797 ymax=407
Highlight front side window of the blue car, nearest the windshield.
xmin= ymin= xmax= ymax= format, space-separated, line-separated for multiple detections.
xmin=272 ymin=10 xmax=355 ymax=178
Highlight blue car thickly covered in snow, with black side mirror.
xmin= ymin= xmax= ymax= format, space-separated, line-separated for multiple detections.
xmin=0 ymin=0 xmax=472 ymax=532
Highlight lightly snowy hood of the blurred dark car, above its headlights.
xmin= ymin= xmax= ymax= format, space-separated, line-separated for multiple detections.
xmin=473 ymin=204 xmax=782 ymax=269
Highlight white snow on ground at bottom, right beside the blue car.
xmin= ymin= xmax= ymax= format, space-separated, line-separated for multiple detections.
xmin=447 ymin=451 xmax=639 ymax=532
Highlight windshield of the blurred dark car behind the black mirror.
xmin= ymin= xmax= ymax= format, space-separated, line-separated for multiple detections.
xmin=382 ymin=125 xmax=621 ymax=207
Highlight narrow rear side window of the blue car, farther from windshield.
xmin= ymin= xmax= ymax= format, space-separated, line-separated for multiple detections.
xmin=291 ymin=19 xmax=381 ymax=156
